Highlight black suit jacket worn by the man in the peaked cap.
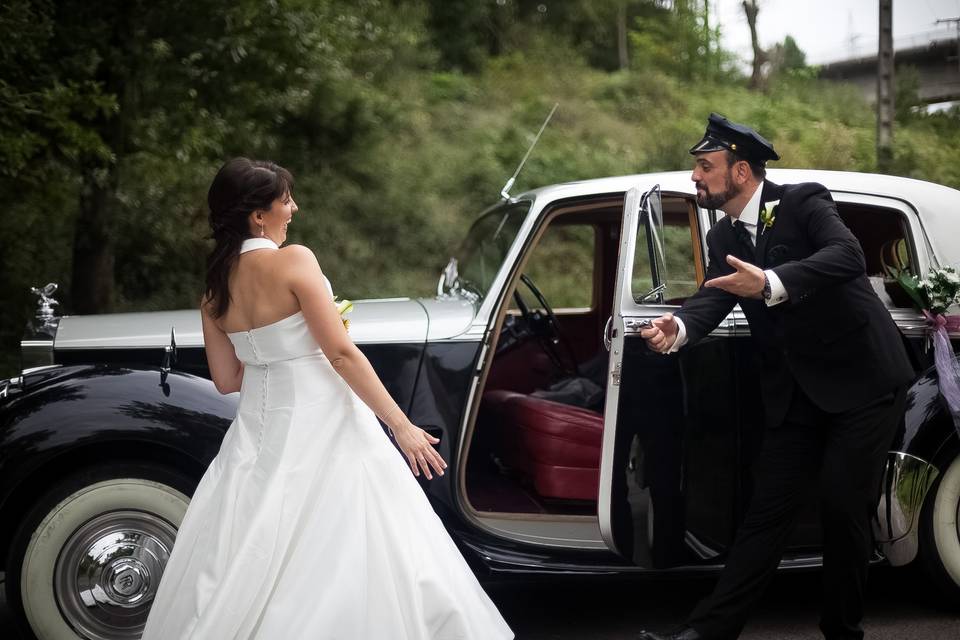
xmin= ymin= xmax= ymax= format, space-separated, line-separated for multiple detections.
xmin=676 ymin=182 xmax=914 ymax=426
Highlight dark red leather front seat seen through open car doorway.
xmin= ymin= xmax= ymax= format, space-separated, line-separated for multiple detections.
xmin=483 ymin=390 xmax=603 ymax=500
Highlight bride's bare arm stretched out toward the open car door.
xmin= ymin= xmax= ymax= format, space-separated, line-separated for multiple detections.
xmin=282 ymin=245 xmax=447 ymax=478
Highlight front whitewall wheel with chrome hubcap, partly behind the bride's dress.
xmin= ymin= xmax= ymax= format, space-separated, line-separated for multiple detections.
xmin=6 ymin=465 xmax=195 ymax=640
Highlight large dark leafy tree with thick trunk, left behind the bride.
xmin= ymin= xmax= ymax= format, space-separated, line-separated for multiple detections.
xmin=0 ymin=0 xmax=421 ymax=313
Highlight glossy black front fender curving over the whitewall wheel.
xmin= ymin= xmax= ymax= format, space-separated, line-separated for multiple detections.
xmin=0 ymin=364 xmax=238 ymax=560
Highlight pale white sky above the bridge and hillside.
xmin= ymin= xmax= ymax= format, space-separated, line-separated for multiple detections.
xmin=710 ymin=0 xmax=960 ymax=64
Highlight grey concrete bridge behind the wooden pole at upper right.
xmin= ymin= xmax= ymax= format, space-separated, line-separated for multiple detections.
xmin=820 ymin=38 xmax=960 ymax=104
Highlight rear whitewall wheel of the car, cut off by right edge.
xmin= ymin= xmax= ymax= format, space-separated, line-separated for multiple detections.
xmin=920 ymin=448 xmax=960 ymax=606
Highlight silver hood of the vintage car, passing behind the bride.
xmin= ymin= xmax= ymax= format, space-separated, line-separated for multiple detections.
xmin=54 ymin=298 xmax=474 ymax=351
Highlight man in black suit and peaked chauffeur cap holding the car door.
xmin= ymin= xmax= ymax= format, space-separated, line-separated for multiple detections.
xmin=640 ymin=114 xmax=913 ymax=640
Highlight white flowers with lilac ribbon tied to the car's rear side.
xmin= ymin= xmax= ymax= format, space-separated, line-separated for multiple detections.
xmin=896 ymin=267 xmax=960 ymax=432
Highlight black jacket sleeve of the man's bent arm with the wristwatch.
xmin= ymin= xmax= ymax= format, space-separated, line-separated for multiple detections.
xmin=773 ymin=184 xmax=866 ymax=304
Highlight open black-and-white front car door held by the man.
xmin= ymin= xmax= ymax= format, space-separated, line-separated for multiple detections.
xmin=598 ymin=185 xmax=743 ymax=568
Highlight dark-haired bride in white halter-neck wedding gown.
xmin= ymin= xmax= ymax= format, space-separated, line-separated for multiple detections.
xmin=142 ymin=158 xmax=513 ymax=640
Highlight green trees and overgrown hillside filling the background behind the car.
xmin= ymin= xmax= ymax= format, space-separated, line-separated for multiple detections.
xmin=0 ymin=0 xmax=960 ymax=377
